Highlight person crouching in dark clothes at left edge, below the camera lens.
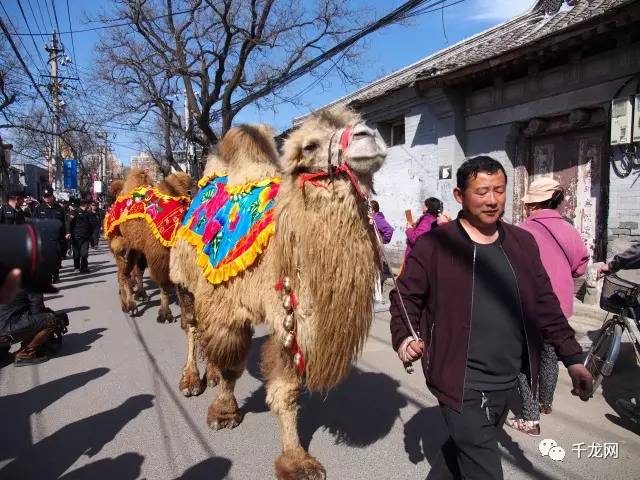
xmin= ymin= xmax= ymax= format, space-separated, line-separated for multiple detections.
xmin=0 ymin=289 xmax=69 ymax=367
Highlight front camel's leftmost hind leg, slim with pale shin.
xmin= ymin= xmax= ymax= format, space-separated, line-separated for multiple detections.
xmin=176 ymin=286 xmax=206 ymax=397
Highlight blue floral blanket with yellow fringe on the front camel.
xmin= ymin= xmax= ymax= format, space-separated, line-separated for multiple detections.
xmin=178 ymin=175 xmax=280 ymax=285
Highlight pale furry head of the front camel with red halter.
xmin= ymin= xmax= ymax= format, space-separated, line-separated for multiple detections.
xmin=283 ymin=107 xmax=387 ymax=193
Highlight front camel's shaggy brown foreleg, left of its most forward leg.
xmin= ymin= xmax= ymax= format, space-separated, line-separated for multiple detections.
xmin=207 ymin=326 xmax=251 ymax=430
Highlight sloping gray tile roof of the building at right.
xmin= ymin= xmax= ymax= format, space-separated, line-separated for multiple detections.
xmin=320 ymin=0 xmax=635 ymax=107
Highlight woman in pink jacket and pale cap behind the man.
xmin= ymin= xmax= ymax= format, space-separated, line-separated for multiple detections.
xmin=507 ymin=177 xmax=589 ymax=436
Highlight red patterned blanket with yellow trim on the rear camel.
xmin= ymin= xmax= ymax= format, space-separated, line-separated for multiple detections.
xmin=104 ymin=186 xmax=190 ymax=247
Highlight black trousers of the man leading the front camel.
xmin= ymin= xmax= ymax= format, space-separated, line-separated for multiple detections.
xmin=436 ymin=388 xmax=515 ymax=480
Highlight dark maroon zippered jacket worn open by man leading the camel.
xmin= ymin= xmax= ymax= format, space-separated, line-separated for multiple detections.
xmin=390 ymin=220 xmax=583 ymax=411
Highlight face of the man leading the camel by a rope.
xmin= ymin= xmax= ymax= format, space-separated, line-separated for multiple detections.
xmin=453 ymin=171 xmax=507 ymax=226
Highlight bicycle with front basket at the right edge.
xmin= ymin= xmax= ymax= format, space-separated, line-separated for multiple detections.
xmin=584 ymin=275 xmax=640 ymax=396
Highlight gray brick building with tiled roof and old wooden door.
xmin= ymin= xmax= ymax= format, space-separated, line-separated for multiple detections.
xmin=306 ymin=0 xmax=640 ymax=270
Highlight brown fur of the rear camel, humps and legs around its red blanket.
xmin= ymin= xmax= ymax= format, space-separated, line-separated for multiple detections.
xmin=113 ymin=168 xmax=193 ymax=323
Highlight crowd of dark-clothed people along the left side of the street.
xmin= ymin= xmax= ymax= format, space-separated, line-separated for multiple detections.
xmin=0 ymin=188 xmax=103 ymax=366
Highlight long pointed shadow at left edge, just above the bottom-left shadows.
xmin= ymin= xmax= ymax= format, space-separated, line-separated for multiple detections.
xmin=0 ymin=368 xmax=109 ymax=464
